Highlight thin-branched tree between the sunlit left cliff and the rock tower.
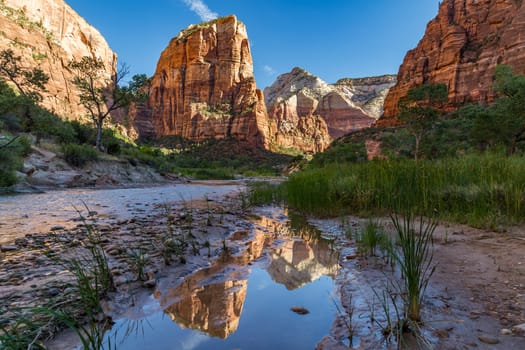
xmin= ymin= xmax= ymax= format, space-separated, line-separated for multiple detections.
xmin=69 ymin=56 xmax=149 ymax=151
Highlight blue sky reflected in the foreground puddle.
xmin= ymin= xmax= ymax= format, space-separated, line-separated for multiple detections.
xmin=106 ymin=268 xmax=335 ymax=350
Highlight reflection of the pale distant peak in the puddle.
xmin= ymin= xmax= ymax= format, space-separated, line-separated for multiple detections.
xmin=268 ymin=239 xmax=339 ymax=290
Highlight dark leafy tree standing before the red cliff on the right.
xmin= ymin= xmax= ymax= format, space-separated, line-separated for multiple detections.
xmin=398 ymin=83 xmax=448 ymax=160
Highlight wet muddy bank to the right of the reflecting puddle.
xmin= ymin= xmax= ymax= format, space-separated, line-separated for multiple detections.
xmin=314 ymin=217 xmax=525 ymax=350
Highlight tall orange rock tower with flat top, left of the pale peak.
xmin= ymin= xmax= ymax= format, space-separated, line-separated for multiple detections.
xmin=139 ymin=16 xmax=268 ymax=147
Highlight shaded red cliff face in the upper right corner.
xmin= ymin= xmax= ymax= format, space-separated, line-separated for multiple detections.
xmin=379 ymin=0 xmax=525 ymax=125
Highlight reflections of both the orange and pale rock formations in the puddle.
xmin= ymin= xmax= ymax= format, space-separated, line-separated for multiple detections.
xmin=151 ymin=206 xmax=339 ymax=339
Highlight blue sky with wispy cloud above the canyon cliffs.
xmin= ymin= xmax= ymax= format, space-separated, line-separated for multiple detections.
xmin=66 ymin=0 xmax=439 ymax=88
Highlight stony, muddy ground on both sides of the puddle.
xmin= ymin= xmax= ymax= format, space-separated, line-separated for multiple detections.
xmin=0 ymin=182 xmax=525 ymax=349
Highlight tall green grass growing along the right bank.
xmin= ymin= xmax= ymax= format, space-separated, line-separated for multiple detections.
xmin=282 ymin=154 xmax=525 ymax=228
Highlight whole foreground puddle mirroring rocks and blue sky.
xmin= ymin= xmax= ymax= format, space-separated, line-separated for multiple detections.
xmin=102 ymin=209 xmax=339 ymax=350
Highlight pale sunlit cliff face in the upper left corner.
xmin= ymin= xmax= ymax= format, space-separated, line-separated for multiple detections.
xmin=0 ymin=0 xmax=117 ymax=119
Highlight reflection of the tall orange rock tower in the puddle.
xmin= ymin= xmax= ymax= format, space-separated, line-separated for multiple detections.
xmin=160 ymin=268 xmax=248 ymax=339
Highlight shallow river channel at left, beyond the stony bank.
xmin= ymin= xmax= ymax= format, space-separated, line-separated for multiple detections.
xmin=0 ymin=182 xmax=238 ymax=244
